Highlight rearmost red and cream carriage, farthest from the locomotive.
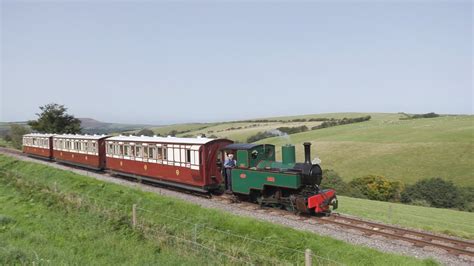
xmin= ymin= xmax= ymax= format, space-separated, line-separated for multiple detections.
xmin=23 ymin=133 xmax=54 ymax=159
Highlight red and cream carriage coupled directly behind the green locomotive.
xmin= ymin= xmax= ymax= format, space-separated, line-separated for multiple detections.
xmin=106 ymin=136 xmax=232 ymax=192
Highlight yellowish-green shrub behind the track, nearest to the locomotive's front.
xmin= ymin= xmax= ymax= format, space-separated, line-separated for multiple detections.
xmin=349 ymin=175 xmax=403 ymax=201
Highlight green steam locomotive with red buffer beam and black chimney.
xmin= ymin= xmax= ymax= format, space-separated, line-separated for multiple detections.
xmin=225 ymin=142 xmax=338 ymax=214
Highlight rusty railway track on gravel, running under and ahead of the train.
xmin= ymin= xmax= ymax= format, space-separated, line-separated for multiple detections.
xmin=0 ymin=147 xmax=474 ymax=261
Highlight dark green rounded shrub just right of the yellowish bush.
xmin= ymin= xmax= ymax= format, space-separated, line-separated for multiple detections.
xmin=401 ymin=178 xmax=462 ymax=208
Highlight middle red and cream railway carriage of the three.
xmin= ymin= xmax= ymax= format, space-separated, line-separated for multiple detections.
xmin=53 ymin=134 xmax=109 ymax=170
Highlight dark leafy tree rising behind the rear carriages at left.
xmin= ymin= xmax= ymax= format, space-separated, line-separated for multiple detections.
xmin=28 ymin=103 xmax=81 ymax=134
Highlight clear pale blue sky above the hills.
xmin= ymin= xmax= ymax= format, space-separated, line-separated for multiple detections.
xmin=0 ymin=0 xmax=474 ymax=124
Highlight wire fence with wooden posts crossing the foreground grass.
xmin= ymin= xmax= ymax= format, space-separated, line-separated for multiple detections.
xmin=1 ymin=171 xmax=344 ymax=265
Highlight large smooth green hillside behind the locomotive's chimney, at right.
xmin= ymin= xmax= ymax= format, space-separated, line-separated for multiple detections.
xmin=260 ymin=114 xmax=474 ymax=185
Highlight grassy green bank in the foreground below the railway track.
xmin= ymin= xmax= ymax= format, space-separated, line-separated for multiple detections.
xmin=0 ymin=155 xmax=434 ymax=265
